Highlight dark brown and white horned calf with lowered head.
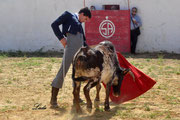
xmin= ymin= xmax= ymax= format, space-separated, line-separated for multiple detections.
xmin=72 ymin=41 xmax=132 ymax=112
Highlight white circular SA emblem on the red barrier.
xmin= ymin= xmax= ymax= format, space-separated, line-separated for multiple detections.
xmin=99 ymin=16 xmax=115 ymax=38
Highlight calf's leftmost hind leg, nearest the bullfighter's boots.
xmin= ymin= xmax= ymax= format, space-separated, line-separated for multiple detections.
xmin=73 ymin=81 xmax=82 ymax=113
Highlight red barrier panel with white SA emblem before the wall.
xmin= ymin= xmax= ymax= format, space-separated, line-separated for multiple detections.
xmin=85 ymin=10 xmax=130 ymax=53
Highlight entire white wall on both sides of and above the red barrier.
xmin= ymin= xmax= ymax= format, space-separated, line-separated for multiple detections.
xmin=0 ymin=0 xmax=180 ymax=53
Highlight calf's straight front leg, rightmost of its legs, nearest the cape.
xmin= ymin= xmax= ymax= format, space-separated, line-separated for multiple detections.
xmin=104 ymin=83 xmax=111 ymax=111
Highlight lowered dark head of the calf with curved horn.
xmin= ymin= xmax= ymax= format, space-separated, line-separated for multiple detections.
xmin=112 ymin=68 xmax=134 ymax=97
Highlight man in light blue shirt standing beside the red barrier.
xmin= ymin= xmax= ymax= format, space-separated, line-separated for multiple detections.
xmin=130 ymin=7 xmax=142 ymax=54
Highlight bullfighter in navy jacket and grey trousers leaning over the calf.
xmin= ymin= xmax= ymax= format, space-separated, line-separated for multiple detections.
xmin=50 ymin=7 xmax=91 ymax=108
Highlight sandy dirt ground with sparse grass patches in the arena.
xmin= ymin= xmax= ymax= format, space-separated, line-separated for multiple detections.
xmin=0 ymin=54 xmax=180 ymax=120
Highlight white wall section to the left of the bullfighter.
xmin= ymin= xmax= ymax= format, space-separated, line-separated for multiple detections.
xmin=0 ymin=0 xmax=83 ymax=51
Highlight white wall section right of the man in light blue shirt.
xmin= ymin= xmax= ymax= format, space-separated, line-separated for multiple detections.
xmin=132 ymin=0 xmax=180 ymax=53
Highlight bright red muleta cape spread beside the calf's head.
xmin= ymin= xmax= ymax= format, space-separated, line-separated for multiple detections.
xmin=103 ymin=52 xmax=156 ymax=104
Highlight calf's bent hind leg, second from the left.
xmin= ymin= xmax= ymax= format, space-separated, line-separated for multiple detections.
xmin=83 ymin=80 xmax=98 ymax=108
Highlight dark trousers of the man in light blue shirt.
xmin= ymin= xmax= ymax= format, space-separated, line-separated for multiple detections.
xmin=131 ymin=30 xmax=138 ymax=54
